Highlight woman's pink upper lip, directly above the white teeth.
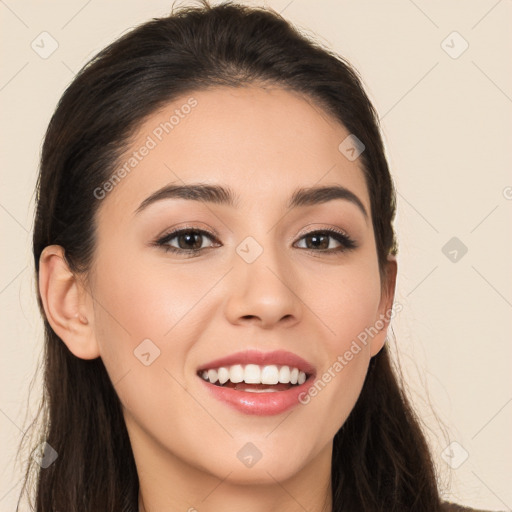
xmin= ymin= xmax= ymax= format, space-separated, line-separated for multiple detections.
xmin=197 ymin=350 xmax=315 ymax=375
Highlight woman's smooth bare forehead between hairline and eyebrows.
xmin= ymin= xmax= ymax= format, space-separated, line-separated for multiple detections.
xmin=100 ymin=86 xmax=370 ymax=222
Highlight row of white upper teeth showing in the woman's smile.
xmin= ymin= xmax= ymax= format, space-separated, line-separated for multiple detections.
xmin=201 ymin=364 xmax=306 ymax=384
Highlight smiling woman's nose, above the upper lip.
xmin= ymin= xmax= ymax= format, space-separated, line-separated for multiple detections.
xmin=225 ymin=237 xmax=303 ymax=329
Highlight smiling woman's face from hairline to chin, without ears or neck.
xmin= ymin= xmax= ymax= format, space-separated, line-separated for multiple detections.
xmin=71 ymin=86 xmax=394 ymax=483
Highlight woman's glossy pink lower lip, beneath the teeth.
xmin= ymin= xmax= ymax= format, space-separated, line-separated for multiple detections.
xmin=198 ymin=376 xmax=315 ymax=416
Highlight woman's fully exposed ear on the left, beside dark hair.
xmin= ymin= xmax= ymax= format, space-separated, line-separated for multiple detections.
xmin=39 ymin=245 xmax=100 ymax=359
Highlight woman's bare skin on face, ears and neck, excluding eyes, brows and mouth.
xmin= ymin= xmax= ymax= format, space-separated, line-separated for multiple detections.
xmin=39 ymin=86 xmax=396 ymax=512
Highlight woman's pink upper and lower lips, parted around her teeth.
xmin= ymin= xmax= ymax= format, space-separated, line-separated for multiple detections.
xmin=197 ymin=350 xmax=316 ymax=416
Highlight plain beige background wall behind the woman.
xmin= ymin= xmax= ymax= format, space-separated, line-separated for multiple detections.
xmin=0 ymin=0 xmax=512 ymax=511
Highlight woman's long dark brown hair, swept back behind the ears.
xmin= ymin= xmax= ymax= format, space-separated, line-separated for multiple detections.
xmin=18 ymin=1 xmax=440 ymax=512
